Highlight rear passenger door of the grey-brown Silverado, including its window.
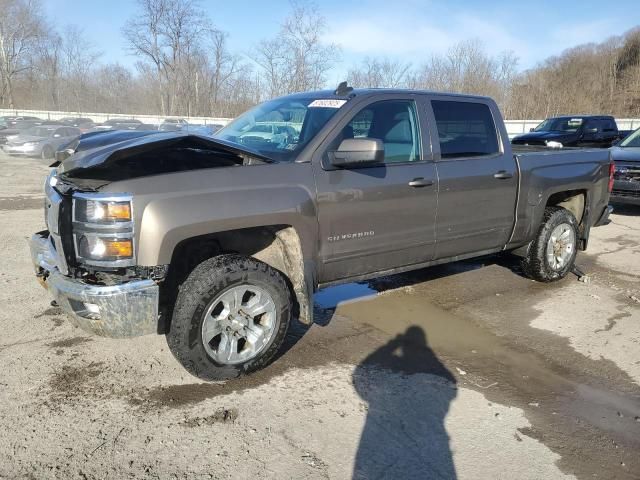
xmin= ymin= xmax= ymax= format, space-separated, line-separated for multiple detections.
xmin=430 ymin=96 xmax=518 ymax=258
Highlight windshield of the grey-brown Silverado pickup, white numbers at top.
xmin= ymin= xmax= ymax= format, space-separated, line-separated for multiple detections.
xmin=213 ymin=97 xmax=346 ymax=162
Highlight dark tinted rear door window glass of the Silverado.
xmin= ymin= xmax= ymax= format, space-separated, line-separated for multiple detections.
xmin=431 ymin=100 xmax=500 ymax=158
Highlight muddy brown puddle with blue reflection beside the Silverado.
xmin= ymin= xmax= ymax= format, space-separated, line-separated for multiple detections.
xmin=119 ymin=264 xmax=640 ymax=478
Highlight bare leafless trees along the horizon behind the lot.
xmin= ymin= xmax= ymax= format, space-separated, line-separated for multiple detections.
xmin=0 ymin=0 xmax=640 ymax=119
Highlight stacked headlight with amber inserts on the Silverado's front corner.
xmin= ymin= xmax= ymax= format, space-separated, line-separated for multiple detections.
xmin=72 ymin=193 xmax=135 ymax=267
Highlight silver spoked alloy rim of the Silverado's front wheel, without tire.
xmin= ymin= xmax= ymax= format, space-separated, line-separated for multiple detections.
xmin=202 ymin=285 xmax=278 ymax=365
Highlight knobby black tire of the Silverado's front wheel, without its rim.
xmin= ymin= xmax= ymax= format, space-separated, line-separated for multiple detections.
xmin=166 ymin=255 xmax=292 ymax=381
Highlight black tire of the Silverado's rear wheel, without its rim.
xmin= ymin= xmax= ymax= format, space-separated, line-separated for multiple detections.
xmin=522 ymin=207 xmax=578 ymax=283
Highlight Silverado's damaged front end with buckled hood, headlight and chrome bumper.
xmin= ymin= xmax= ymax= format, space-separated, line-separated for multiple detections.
xmin=30 ymin=134 xmax=267 ymax=338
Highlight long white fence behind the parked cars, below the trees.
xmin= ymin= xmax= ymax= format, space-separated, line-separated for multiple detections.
xmin=0 ymin=109 xmax=640 ymax=138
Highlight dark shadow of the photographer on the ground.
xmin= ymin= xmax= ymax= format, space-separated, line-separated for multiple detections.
xmin=353 ymin=326 xmax=457 ymax=480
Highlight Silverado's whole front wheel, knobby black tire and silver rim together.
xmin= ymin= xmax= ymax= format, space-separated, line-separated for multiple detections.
xmin=167 ymin=255 xmax=292 ymax=380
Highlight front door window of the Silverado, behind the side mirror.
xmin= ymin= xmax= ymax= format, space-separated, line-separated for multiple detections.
xmin=328 ymin=100 xmax=421 ymax=164
